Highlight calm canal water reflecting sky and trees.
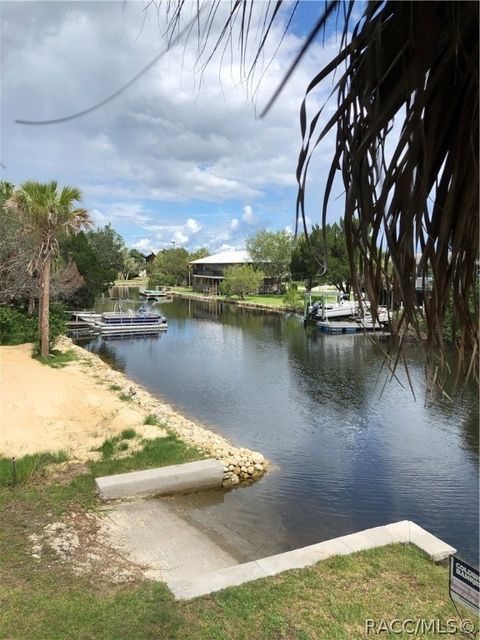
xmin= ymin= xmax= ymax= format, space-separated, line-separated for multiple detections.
xmin=79 ymin=289 xmax=479 ymax=562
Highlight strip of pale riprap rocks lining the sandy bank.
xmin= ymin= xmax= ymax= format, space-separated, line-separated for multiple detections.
xmin=57 ymin=336 xmax=268 ymax=488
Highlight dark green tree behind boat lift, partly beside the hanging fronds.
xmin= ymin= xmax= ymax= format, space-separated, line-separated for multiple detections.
xmin=291 ymin=219 xmax=352 ymax=293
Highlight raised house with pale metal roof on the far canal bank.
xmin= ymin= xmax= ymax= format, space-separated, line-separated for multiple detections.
xmin=189 ymin=249 xmax=277 ymax=294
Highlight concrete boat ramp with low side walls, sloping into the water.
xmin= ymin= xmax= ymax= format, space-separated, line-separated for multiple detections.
xmin=97 ymin=461 xmax=456 ymax=600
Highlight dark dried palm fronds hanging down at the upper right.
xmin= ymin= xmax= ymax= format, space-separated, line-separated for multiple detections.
xmin=297 ymin=2 xmax=479 ymax=390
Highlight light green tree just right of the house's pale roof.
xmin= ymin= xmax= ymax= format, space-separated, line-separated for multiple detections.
xmin=246 ymin=230 xmax=293 ymax=287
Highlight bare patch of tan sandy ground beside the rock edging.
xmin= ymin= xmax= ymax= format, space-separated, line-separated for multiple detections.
xmin=0 ymin=344 xmax=150 ymax=460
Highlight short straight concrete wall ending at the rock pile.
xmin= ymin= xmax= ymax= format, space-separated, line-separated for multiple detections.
xmin=95 ymin=458 xmax=223 ymax=500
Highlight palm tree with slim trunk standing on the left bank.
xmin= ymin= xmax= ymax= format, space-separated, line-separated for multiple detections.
xmin=5 ymin=180 xmax=91 ymax=356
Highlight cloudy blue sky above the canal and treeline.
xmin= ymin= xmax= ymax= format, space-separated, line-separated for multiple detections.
xmin=1 ymin=1 xmax=350 ymax=252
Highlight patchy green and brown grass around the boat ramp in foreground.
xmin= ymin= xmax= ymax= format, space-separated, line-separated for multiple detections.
xmin=0 ymin=444 xmax=468 ymax=640
